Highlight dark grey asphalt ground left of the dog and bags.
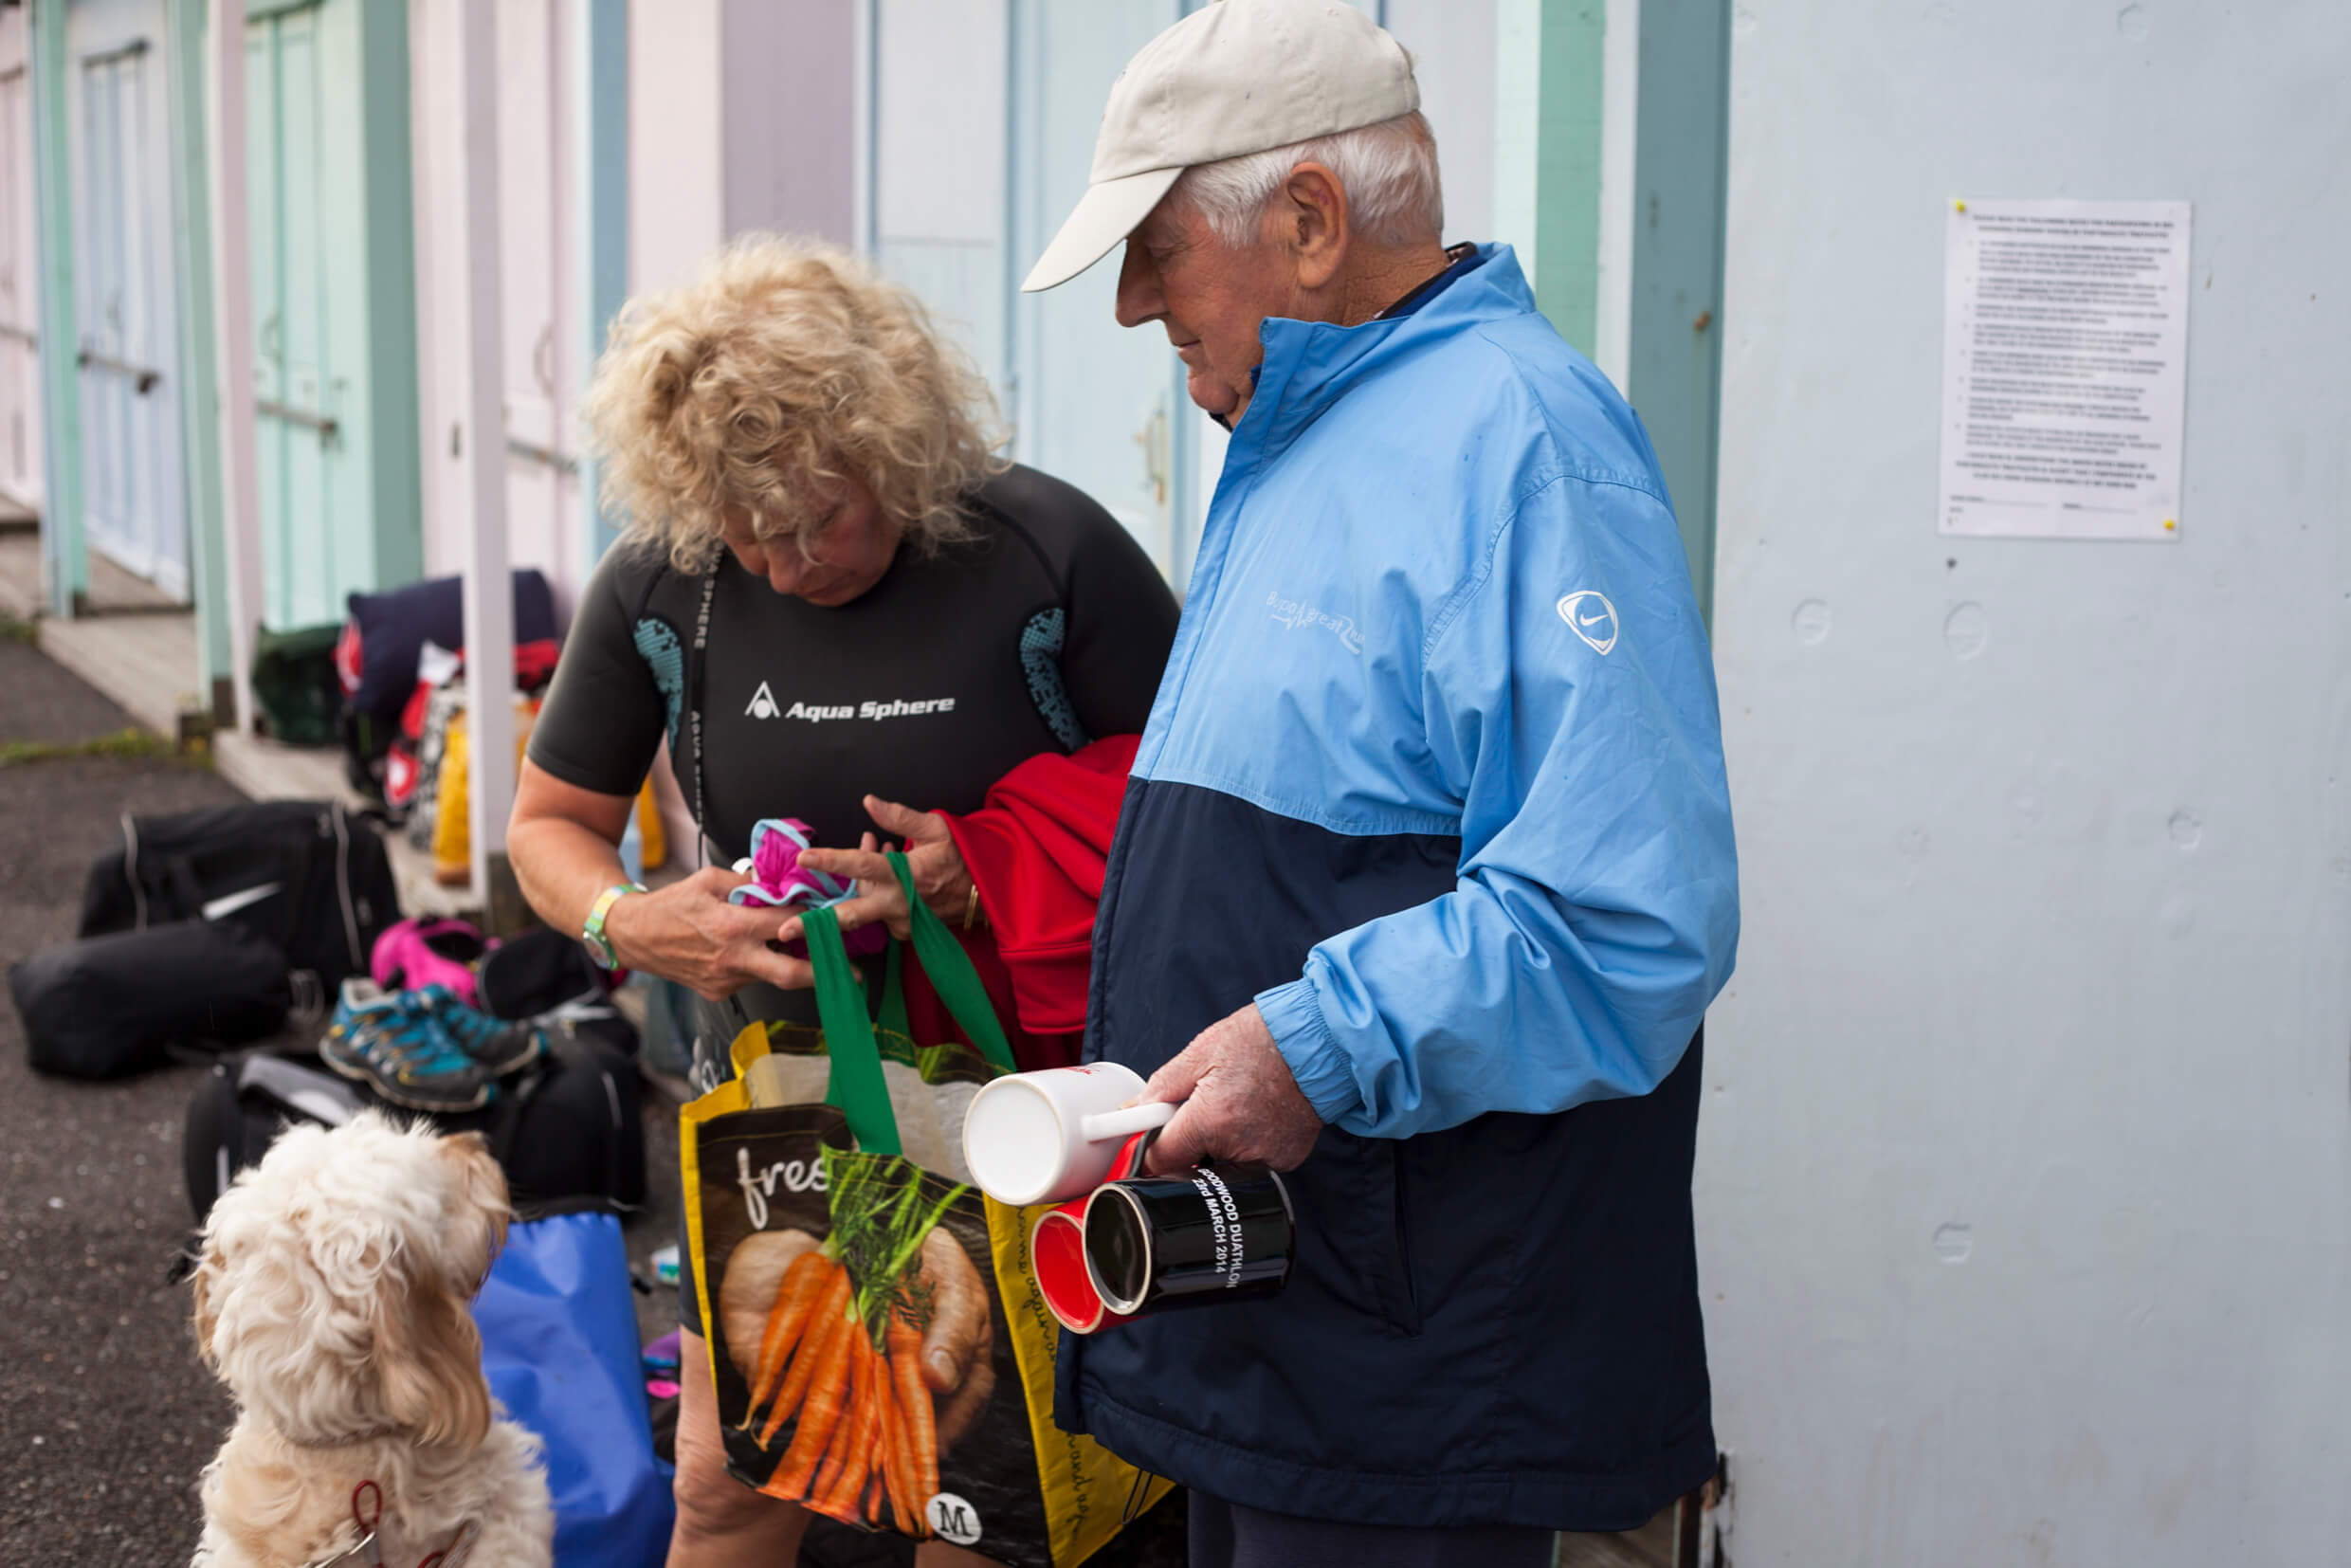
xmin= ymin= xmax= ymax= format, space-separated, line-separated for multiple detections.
xmin=0 ymin=637 xmax=240 ymax=1568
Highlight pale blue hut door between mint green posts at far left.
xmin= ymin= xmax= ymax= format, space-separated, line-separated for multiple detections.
xmin=75 ymin=47 xmax=188 ymax=597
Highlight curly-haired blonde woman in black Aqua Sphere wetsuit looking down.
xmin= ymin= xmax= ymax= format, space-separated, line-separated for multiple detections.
xmin=508 ymin=237 xmax=1176 ymax=1568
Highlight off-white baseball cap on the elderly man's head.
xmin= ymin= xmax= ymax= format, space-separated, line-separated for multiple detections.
xmin=1020 ymin=0 xmax=1420 ymax=294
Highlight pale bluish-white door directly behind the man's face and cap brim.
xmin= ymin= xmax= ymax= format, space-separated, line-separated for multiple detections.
xmin=1009 ymin=0 xmax=1190 ymax=576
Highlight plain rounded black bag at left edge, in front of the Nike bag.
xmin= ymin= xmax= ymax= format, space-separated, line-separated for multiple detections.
xmin=7 ymin=920 xmax=294 ymax=1079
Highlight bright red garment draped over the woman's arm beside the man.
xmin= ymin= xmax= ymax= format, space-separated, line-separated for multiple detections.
xmin=905 ymin=736 xmax=1142 ymax=1069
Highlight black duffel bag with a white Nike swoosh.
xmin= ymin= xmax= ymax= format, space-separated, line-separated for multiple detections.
xmin=78 ymin=799 xmax=400 ymax=994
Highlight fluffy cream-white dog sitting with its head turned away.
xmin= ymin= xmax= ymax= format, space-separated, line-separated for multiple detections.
xmin=195 ymin=1112 xmax=555 ymax=1568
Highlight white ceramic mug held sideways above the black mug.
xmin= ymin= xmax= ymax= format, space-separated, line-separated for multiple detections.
xmin=964 ymin=1063 xmax=1176 ymax=1204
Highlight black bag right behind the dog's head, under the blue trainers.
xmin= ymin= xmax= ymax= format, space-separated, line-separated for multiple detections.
xmin=181 ymin=1020 xmax=645 ymax=1225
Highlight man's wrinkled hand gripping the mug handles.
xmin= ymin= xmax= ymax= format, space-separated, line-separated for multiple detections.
xmin=1136 ymin=1001 xmax=1323 ymax=1176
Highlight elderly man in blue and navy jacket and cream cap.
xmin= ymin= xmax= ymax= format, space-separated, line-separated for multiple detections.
xmin=1028 ymin=0 xmax=1738 ymax=1568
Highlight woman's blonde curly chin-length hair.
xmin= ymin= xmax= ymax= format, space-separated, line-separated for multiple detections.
xmin=583 ymin=235 xmax=1006 ymax=574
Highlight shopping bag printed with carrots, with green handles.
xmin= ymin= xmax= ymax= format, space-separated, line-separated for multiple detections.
xmin=680 ymin=853 xmax=1169 ymax=1568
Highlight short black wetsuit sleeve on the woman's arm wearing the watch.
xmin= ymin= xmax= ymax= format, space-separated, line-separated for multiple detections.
xmin=529 ymin=550 xmax=682 ymax=794
